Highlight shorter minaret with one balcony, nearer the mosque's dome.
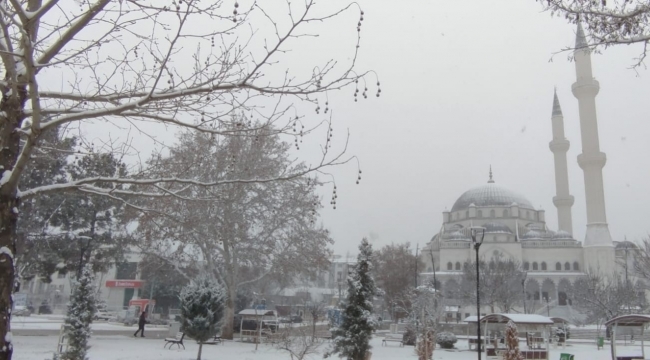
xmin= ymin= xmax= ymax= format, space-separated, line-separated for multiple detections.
xmin=548 ymin=91 xmax=574 ymax=234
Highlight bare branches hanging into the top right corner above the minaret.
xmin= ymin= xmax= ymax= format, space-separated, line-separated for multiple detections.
xmin=537 ymin=0 xmax=650 ymax=67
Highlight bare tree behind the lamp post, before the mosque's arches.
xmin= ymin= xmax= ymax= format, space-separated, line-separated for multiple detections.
xmin=460 ymin=253 xmax=525 ymax=313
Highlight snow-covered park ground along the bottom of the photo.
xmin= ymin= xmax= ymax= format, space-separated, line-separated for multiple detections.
xmin=14 ymin=336 xmax=650 ymax=360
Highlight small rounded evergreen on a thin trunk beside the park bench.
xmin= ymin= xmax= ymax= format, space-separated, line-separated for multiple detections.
xmin=180 ymin=276 xmax=225 ymax=360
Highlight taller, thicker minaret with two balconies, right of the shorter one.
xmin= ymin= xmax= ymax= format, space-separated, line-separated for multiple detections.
xmin=571 ymin=23 xmax=614 ymax=274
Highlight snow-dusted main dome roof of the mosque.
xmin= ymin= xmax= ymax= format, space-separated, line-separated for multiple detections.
xmin=451 ymin=182 xmax=535 ymax=211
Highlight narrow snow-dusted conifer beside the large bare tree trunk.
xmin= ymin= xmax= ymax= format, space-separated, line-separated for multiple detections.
xmin=61 ymin=265 xmax=96 ymax=360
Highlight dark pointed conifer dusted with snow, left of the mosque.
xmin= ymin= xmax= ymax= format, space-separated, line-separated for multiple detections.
xmin=325 ymin=238 xmax=376 ymax=360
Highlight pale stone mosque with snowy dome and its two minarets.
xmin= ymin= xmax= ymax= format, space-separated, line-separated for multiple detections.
xmin=420 ymin=25 xmax=630 ymax=319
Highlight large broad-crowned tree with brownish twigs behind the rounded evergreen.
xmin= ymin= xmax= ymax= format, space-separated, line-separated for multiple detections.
xmin=141 ymin=127 xmax=332 ymax=338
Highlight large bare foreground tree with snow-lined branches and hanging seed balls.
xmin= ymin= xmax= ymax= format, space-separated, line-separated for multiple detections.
xmin=0 ymin=0 xmax=380 ymax=360
